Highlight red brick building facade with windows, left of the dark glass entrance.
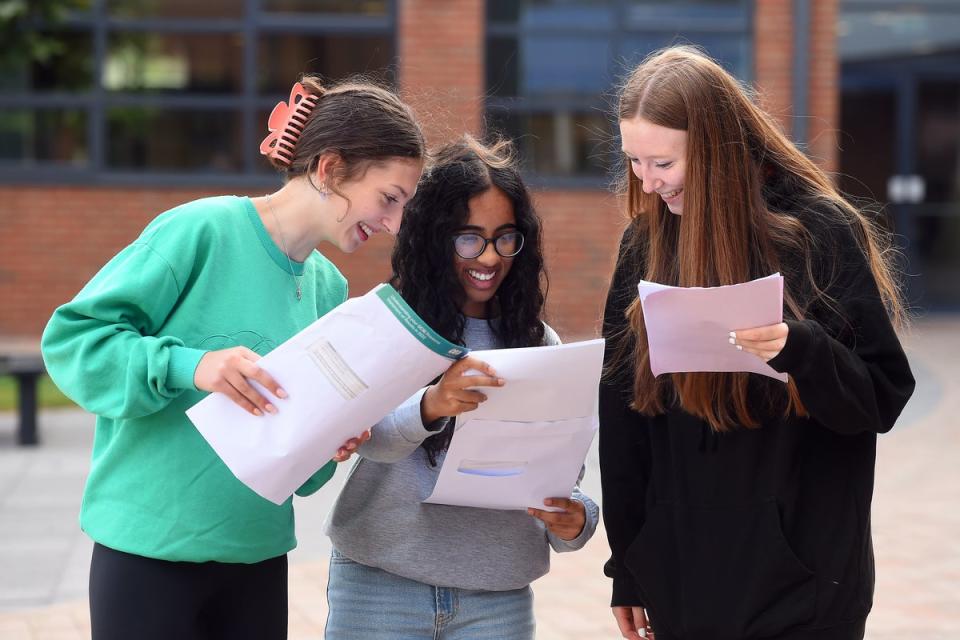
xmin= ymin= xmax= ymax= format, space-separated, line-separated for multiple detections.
xmin=0 ymin=0 xmax=841 ymax=339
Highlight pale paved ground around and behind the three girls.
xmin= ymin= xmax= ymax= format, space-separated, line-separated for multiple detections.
xmin=0 ymin=317 xmax=960 ymax=640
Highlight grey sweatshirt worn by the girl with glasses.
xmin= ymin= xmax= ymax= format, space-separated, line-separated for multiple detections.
xmin=324 ymin=318 xmax=599 ymax=591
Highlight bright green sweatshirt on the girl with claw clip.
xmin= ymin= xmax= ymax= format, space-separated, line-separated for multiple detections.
xmin=42 ymin=196 xmax=347 ymax=563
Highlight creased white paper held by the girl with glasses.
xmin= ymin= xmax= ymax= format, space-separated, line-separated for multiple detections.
xmin=424 ymin=340 xmax=604 ymax=510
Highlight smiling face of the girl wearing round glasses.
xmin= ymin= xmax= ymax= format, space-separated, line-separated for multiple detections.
xmin=450 ymin=187 xmax=517 ymax=318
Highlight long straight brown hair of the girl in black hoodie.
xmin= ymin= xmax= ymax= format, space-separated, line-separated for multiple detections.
xmin=608 ymin=46 xmax=905 ymax=431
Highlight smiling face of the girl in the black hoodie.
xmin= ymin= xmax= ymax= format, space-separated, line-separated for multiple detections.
xmin=620 ymin=118 xmax=687 ymax=215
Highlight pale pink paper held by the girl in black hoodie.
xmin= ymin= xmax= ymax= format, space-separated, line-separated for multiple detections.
xmin=639 ymin=273 xmax=787 ymax=382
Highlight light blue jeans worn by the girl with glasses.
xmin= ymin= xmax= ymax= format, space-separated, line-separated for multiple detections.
xmin=324 ymin=549 xmax=536 ymax=640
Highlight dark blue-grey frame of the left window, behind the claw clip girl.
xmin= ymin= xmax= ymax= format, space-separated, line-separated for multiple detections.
xmin=0 ymin=0 xmax=399 ymax=187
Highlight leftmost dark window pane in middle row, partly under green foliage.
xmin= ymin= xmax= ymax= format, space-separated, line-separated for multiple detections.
xmin=0 ymin=31 xmax=93 ymax=91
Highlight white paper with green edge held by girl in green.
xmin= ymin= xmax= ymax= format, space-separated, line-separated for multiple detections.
xmin=187 ymin=285 xmax=466 ymax=504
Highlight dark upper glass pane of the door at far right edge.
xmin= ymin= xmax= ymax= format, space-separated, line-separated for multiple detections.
xmin=916 ymin=80 xmax=960 ymax=202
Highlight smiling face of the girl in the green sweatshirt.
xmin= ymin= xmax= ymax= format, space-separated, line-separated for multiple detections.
xmin=329 ymin=158 xmax=423 ymax=253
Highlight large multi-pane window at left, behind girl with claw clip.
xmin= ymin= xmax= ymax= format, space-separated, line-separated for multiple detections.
xmin=0 ymin=0 xmax=396 ymax=184
